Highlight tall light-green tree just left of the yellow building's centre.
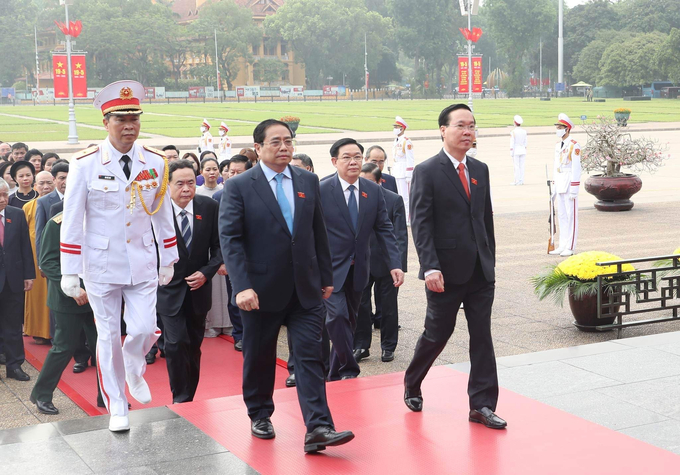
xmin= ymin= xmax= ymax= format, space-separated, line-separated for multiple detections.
xmin=190 ymin=0 xmax=260 ymax=89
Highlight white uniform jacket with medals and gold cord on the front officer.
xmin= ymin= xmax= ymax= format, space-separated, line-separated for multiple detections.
xmin=61 ymin=139 xmax=178 ymax=285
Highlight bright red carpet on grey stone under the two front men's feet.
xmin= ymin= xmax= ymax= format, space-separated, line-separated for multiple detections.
xmin=170 ymin=367 xmax=680 ymax=475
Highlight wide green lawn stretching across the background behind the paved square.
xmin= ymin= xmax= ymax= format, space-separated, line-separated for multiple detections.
xmin=0 ymin=98 xmax=680 ymax=142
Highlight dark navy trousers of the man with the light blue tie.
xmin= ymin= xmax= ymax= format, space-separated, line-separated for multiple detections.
xmin=241 ymin=291 xmax=334 ymax=432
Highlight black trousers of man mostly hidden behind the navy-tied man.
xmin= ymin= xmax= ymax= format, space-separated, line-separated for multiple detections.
xmin=354 ymin=274 xmax=399 ymax=351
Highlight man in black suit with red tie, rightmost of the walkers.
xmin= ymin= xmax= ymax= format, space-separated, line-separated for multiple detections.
xmin=404 ymin=104 xmax=507 ymax=429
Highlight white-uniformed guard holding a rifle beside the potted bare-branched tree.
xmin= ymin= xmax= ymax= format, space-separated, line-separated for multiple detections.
xmin=550 ymin=114 xmax=581 ymax=257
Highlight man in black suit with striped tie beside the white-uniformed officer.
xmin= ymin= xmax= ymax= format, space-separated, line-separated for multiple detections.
xmin=156 ymin=160 xmax=222 ymax=403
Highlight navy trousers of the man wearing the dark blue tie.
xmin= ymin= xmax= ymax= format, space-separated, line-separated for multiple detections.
xmin=324 ymin=266 xmax=361 ymax=381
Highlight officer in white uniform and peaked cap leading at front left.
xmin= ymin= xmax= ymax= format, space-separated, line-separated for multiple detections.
xmin=60 ymin=81 xmax=178 ymax=431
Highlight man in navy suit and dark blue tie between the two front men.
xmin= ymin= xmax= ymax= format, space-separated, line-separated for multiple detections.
xmin=318 ymin=138 xmax=404 ymax=381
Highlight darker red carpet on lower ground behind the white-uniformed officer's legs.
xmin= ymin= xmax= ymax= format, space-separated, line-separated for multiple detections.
xmin=24 ymin=335 xmax=288 ymax=416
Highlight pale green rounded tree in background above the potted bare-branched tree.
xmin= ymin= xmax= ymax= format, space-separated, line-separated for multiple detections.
xmin=598 ymin=31 xmax=668 ymax=87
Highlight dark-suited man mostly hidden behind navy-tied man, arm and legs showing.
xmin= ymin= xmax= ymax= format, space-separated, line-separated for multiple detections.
xmin=354 ymin=163 xmax=408 ymax=362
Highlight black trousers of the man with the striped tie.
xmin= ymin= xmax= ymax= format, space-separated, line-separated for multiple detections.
xmin=160 ymin=291 xmax=206 ymax=403
